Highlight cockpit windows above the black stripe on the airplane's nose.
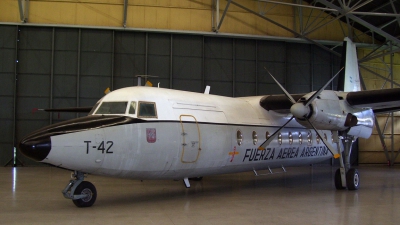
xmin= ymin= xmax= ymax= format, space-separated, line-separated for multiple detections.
xmin=89 ymin=101 xmax=157 ymax=118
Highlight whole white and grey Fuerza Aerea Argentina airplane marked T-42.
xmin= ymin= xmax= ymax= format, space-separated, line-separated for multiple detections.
xmin=19 ymin=39 xmax=400 ymax=207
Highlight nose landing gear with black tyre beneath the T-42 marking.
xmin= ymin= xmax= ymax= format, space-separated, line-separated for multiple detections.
xmin=62 ymin=171 xmax=97 ymax=207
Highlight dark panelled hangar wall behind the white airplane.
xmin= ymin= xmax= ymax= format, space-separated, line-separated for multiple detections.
xmin=0 ymin=25 xmax=340 ymax=165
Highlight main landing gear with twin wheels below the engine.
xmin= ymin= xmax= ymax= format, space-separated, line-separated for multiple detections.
xmin=335 ymin=134 xmax=360 ymax=190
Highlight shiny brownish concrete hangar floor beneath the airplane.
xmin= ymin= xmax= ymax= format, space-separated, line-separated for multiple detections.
xmin=0 ymin=166 xmax=400 ymax=225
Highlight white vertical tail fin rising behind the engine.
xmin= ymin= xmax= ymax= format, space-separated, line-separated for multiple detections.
xmin=338 ymin=37 xmax=361 ymax=92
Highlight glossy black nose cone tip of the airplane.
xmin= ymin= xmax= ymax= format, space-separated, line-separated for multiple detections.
xmin=19 ymin=136 xmax=51 ymax=161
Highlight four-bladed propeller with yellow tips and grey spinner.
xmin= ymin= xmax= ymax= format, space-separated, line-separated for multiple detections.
xmin=258 ymin=67 xmax=344 ymax=159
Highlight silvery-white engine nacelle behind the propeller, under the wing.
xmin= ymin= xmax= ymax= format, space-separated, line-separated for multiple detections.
xmin=296 ymin=90 xmax=374 ymax=138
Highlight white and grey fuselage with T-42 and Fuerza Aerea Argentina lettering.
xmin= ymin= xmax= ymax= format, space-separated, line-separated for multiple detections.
xmin=20 ymin=87 xmax=336 ymax=179
